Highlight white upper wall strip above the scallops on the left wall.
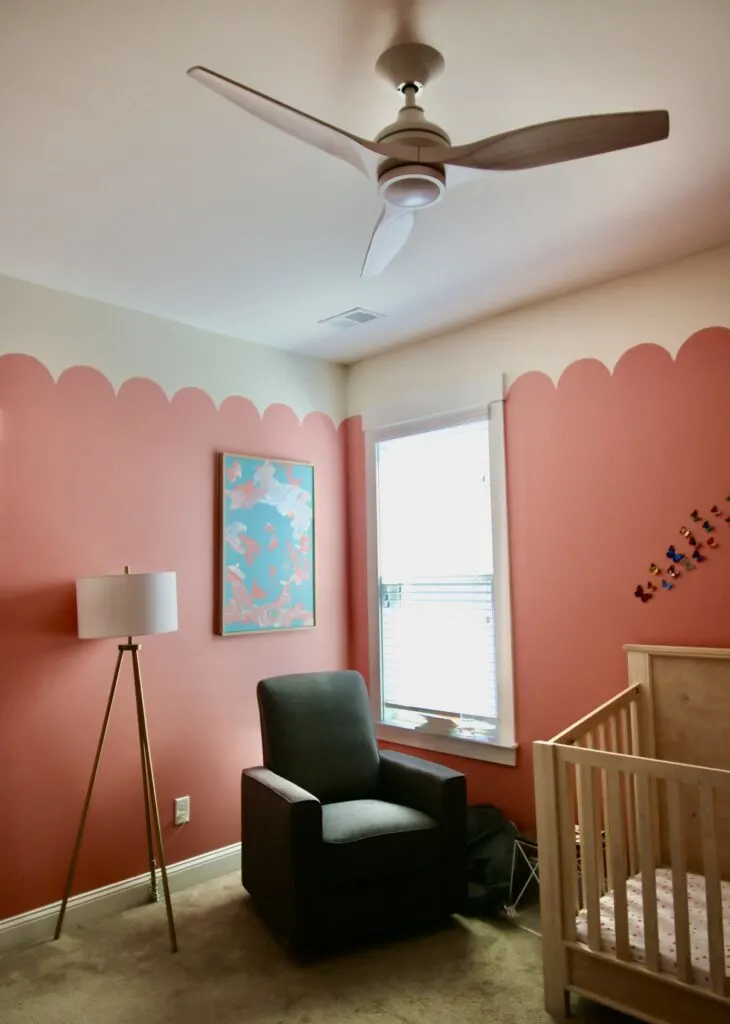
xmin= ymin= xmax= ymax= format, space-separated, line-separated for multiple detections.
xmin=0 ymin=276 xmax=345 ymax=424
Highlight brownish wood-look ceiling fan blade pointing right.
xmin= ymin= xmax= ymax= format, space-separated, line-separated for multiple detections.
xmin=419 ymin=111 xmax=670 ymax=173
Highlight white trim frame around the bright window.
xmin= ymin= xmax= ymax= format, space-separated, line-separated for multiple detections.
xmin=366 ymin=391 xmax=517 ymax=765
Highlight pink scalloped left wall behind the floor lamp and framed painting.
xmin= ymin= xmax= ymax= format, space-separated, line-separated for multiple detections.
xmin=0 ymin=355 xmax=347 ymax=918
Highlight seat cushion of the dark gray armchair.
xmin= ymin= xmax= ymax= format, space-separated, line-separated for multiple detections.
xmin=321 ymin=800 xmax=441 ymax=883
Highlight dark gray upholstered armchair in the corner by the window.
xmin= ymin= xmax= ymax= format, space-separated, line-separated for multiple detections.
xmin=242 ymin=672 xmax=467 ymax=950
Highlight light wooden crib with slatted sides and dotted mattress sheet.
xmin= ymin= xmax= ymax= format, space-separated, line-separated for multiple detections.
xmin=534 ymin=646 xmax=730 ymax=1024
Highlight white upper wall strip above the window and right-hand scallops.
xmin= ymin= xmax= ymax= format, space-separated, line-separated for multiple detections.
xmin=348 ymin=245 xmax=730 ymax=423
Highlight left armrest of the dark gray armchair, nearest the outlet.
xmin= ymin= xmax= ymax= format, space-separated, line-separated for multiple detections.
xmin=241 ymin=768 xmax=321 ymax=946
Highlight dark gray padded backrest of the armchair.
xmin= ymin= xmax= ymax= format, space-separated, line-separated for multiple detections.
xmin=257 ymin=672 xmax=380 ymax=804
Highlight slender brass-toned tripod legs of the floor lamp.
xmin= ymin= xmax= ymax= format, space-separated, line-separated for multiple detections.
xmin=53 ymin=637 xmax=177 ymax=952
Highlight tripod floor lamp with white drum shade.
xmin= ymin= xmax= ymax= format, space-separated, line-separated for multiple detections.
xmin=54 ymin=566 xmax=177 ymax=952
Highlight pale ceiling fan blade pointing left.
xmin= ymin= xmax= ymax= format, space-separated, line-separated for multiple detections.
xmin=187 ymin=67 xmax=407 ymax=177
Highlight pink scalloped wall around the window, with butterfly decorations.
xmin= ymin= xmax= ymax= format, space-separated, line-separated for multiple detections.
xmin=348 ymin=328 xmax=730 ymax=824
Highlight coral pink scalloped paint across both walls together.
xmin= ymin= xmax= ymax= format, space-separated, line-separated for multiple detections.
xmin=5 ymin=328 xmax=730 ymax=918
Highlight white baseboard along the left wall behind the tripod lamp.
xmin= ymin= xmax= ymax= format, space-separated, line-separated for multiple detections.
xmin=0 ymin=843 xmax=241 ymax=953
